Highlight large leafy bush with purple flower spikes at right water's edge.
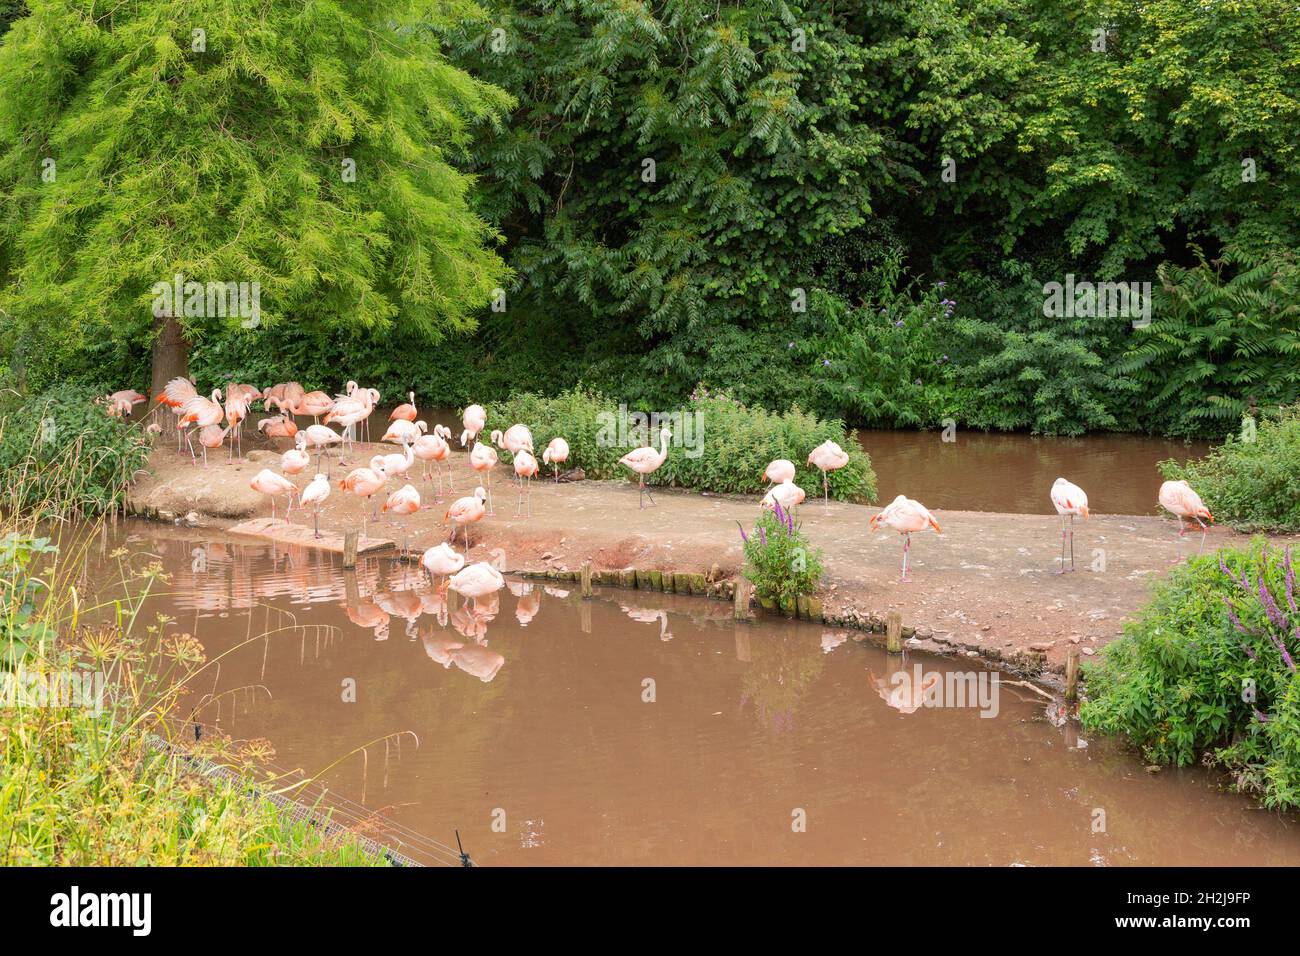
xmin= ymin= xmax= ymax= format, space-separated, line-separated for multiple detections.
xmin=1082 ymin=540 xmax=1300 ymax=808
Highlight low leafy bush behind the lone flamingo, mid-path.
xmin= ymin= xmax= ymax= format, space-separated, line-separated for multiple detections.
xmin=486 ymin=388 xmax=876 ymax=501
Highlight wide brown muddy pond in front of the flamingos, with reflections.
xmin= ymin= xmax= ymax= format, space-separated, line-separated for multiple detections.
xmin=88 ymin=522 xmax=1300 ymax=866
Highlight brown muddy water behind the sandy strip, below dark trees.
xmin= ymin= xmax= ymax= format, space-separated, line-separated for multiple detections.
xmin=395 ymin=407 xmax=1209 ymax=515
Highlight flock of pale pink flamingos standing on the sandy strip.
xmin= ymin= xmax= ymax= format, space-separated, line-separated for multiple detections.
xmin=103 ymin=378 xmax=1214 ymax=600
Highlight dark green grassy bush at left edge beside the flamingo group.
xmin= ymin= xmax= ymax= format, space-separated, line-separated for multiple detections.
xmin=0 ymin=386 xmax=150 ymax=515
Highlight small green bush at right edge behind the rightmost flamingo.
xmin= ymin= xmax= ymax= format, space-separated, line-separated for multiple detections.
xmin=1160 ymin=406 xmax=1300 ymax=531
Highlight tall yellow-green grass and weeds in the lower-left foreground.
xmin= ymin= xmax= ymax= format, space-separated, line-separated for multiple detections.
xmin=0 ymin=455 xmax=376 ymax=866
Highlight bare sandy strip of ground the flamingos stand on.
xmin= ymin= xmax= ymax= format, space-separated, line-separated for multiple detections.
xmin=131 ymin=446 xmax=1281 ymax=667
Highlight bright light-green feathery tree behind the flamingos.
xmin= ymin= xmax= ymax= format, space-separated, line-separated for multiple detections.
xmin=0 ymin=0 xmax=511 ymax=403
